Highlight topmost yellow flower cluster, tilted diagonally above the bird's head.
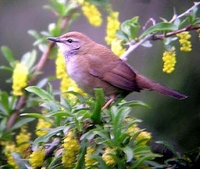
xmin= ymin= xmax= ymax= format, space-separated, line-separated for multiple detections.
xmin=82 ymin=2 xmax=102 ymax=27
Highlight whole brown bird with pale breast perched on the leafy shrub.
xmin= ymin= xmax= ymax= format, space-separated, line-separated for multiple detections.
xmin=48 ymin=32 xmax=187 ymax=109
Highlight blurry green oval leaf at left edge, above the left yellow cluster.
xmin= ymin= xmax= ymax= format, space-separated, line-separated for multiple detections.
xmin=1 ymin=46 xmax=15 ymax=67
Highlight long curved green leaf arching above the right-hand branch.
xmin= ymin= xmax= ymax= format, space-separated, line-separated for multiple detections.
xmin=139 ymin=22 xmax=178 ymax=39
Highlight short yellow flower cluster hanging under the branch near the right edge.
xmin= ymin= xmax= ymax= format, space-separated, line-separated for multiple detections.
xmin=176 ymin=32 xmax=192 ymax=52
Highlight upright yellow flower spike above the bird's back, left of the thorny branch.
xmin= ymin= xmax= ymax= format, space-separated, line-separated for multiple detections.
xmin=105 ymin=12 xmax=120 ymax=45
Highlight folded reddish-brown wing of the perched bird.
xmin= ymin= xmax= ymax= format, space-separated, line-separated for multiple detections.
xmin=89 ymin=59 xmax=140 ymax=91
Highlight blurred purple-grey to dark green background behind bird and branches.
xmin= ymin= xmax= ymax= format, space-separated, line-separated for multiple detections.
xmin=0 ymin=0 xmax=200 ymax=151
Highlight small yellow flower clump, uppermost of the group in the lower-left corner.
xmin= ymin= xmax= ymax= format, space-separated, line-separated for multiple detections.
xmin=35 ymin=119 xmax=52 ymax=136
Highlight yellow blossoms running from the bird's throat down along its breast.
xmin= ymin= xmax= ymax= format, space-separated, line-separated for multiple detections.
xmin=56 ymin=50 xmax=85 ymax=102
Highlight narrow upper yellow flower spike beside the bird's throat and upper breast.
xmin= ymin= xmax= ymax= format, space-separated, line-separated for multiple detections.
xmin=55 ymin=50 xmax=67 ymax=79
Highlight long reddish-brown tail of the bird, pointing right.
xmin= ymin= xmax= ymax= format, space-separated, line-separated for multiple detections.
xmin=136 ymin=75 xmax=187 ymax=100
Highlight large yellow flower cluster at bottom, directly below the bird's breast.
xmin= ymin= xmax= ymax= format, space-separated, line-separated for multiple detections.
xmin=62 ymin=131 xmax=80 ymax=168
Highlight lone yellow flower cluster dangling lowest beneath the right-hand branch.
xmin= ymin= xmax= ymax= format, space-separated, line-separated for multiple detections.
xmin=162 ymin=47 xmax=176 ymax=73
